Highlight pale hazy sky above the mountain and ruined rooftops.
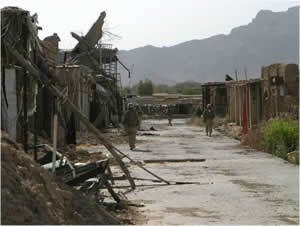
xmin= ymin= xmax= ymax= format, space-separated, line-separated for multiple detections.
xmin=0 ymin=0 xmax=299 ymax=49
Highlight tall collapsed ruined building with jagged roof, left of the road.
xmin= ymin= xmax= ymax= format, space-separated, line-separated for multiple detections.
xmin=1 ymin=7 xmax=122 ymax=148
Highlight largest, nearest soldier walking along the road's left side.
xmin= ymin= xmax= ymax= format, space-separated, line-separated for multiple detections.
xmin=123 ymin=103 xmax=139 ymax=150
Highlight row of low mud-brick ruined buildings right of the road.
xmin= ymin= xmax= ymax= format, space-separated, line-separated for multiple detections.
xmin=202 ymin=64 xmax=299 ymax=132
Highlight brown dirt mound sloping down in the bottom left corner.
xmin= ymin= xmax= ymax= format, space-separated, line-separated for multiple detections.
xmin=1 ymin=132 xmax=118 ymax=225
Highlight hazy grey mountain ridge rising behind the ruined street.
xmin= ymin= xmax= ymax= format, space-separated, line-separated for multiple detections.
xmin=118 ymin=7 xmax=299 ymax=85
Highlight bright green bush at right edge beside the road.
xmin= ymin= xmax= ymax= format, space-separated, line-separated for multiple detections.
xmin=263 ymin=119 xmax=299 ymax=159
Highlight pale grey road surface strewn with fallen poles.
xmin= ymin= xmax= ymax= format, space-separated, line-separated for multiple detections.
xmin=93 ymin=120 xmax=299 ymax=224
